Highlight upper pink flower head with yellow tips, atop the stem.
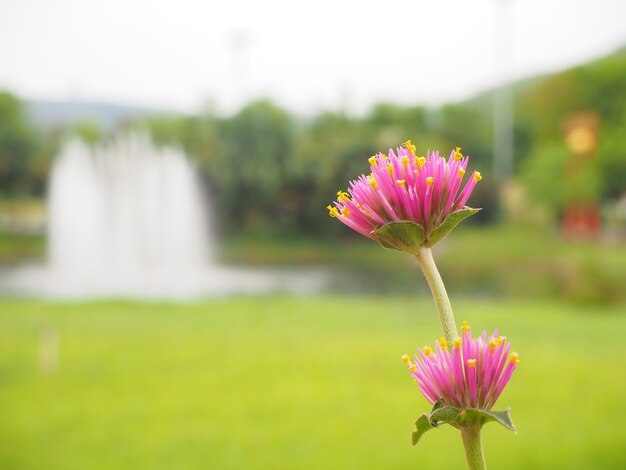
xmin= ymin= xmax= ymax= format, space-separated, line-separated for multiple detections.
xmin=327 ymin=140 xmax=482 ymax=251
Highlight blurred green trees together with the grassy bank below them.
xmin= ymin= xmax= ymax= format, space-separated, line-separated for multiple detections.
xmin=0 ymin=49 xmax=626 ymax=301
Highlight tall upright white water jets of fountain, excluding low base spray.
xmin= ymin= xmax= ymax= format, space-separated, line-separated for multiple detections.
xmin=48 ymin=135 xmax=211 ymax=279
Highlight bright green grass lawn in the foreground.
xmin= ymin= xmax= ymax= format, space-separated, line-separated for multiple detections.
xmin=0 ymin=296 xmax=626 ymax=469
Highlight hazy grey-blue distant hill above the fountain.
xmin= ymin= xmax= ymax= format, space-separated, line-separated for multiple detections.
xmin=25 ymin=100 xmax=175 ymax=129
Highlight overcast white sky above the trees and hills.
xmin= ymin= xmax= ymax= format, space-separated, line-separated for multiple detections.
xmin=0 ymin=0 xmax=626 ymax=114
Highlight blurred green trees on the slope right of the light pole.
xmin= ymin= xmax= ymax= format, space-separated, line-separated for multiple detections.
xmin=518 ymin=50 xmax=626 ymax=215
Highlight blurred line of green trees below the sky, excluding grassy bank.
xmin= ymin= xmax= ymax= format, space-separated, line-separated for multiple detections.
xmin=0 ymin=47 xmax=626 ymax=236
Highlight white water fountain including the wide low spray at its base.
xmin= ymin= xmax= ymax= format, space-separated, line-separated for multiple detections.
xmin=0 ymin=134 xmax=325 ymax=299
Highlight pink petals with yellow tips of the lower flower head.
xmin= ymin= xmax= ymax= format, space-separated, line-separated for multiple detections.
xmin=402 ymin=322 xmax=520 ymax=411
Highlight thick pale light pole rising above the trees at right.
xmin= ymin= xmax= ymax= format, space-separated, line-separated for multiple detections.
xmin=492 ymin=0 xmax=514 ymax=184
